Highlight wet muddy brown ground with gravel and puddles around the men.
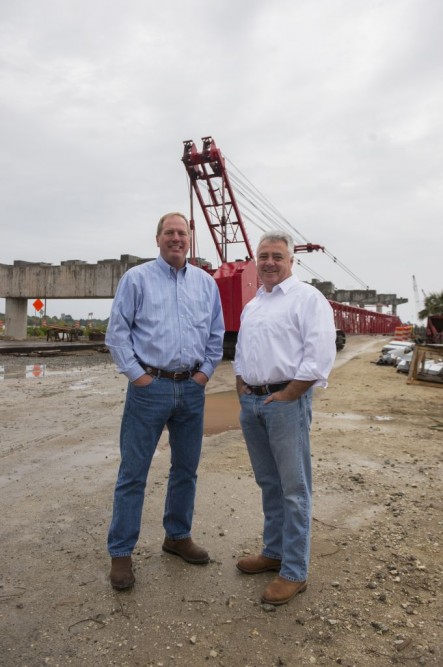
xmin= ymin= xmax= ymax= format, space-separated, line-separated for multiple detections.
xmin=0 ymin=337 xmax=443 ymax=667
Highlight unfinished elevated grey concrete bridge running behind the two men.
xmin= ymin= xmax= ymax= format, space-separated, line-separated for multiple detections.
xmin=0 ymin=255 xmax=408 ymax=340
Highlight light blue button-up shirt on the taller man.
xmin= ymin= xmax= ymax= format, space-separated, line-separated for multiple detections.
xmin=105 ymin=256 xmax=224 ymax=382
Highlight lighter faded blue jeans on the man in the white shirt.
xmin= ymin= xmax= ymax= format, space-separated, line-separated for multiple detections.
xmin=240 ymin=389 xmax=312 ymax=581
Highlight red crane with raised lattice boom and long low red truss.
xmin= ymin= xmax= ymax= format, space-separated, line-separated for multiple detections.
xmin=182 ymin=136 xmax=401 ymax=358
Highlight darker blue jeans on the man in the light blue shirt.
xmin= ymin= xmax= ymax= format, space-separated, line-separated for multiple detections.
xmin=108 ymin=378 xmax=205 ymax=558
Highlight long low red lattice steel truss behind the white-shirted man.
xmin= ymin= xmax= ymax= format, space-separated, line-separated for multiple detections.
xmin=329 ymin=301 xmax=402 ymax=335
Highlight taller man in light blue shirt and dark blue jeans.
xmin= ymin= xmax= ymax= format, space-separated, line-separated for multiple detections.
xmin=106 ymin=213 xmax=224 ymax=590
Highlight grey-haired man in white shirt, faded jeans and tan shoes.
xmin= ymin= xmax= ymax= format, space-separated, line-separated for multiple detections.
xmin=234 ymin=231 xmax=336 ymax=605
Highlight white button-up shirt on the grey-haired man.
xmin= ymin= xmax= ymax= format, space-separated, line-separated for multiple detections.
xmin=233 ymin=275 xmax=336 ymax=387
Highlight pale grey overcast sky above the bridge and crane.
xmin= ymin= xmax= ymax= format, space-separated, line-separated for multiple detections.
xmin=0 ymin=0 xmax=443 ymax=321
